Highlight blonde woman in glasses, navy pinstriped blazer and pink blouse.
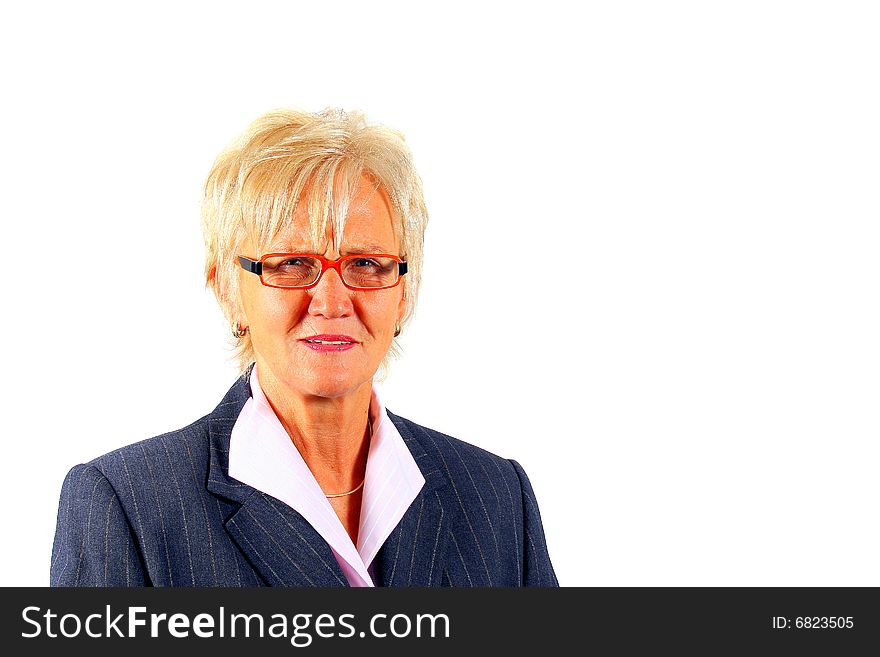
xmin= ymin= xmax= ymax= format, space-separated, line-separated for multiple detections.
xmin=51 ymin=110 xmax=557 ymax=586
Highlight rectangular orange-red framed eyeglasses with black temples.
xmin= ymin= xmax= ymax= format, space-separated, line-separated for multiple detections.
xmin=238 ymin=253 xmax=406 ymax=290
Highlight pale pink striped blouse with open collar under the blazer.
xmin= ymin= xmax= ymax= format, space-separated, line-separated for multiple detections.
xmin=229 ymin=365 xmax=425 ymax=586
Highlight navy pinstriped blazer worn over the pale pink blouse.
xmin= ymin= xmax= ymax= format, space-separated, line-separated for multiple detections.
xmin=51 ymin=375 xmax=558 ymax=586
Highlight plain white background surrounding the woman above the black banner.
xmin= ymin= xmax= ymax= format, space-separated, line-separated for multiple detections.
xmin=0 ymin=1 xmax=880 ymax=586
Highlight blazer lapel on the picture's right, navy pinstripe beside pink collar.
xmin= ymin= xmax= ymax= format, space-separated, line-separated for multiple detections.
xmin=375 ymin=412 xmax=454 ymax=586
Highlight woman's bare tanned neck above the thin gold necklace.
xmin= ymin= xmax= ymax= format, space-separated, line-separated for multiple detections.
xmin=258 ymin=367 xmax=372 ymax=493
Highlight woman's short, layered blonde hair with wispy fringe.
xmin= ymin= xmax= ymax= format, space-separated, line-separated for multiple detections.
xmin=202 ymin=109 xmax=428 ymax=375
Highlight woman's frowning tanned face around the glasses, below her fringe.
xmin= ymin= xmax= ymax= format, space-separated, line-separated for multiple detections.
xmin=237 ymin=179 xmax=405 ymax=397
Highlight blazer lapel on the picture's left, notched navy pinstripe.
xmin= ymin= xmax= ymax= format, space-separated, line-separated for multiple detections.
xmin=207 ymin=372 xmax=348 ymax=586
